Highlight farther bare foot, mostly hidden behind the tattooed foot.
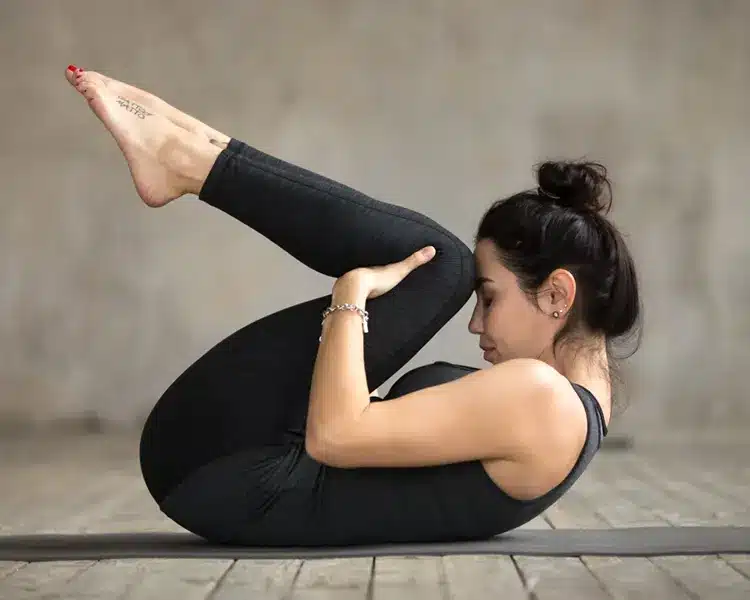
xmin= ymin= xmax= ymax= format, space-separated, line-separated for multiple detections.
xmin=65 ymin=65 xmax=230 ymax=147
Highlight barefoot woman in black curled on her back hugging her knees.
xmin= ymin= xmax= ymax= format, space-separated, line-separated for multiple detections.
xmin=67 ymin=66 xmax=639 ymax=545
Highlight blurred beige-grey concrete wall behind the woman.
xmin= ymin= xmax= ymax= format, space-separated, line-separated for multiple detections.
xmin=0 ymin=0 xmax=750 ymax=437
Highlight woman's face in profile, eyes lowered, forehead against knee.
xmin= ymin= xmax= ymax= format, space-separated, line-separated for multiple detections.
xmin=469 ymin=240 xmax=565 ymax=364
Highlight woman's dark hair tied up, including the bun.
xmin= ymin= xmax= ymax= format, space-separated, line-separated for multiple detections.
xmin=475 ymin=161 xmax=641 ymax=400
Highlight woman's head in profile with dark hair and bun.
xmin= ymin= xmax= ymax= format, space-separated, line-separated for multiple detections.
xmin=469 ymin=162 xmax=640 ymax=376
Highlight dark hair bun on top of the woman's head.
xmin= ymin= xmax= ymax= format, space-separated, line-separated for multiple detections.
xmin=536 ymin=161 xmax=612 ymax=213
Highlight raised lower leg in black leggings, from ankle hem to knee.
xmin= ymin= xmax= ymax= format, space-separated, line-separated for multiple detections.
xmin=199 ymin=139 xmax=472 ymax=278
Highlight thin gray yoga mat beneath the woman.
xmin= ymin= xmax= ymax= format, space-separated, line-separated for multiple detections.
xmin=0 ymin=527 xmax=750 ymax=562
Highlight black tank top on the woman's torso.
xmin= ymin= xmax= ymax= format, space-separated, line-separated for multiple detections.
xmin=274 ymin=362 xmax=607 ymax=545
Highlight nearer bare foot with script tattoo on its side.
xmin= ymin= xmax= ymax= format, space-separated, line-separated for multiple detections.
xmin=68 ymin=65 xmax=220 ymax=207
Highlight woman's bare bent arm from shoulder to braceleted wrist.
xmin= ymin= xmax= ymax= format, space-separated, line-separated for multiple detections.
xmin=306 ymin=279 xmax=568 ymax=467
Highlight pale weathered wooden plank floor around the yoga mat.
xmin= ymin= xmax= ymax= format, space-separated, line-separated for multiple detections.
xmin=0 ymin=436 xmax=750 ymax=600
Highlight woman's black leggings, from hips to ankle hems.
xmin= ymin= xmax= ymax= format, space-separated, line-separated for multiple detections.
xmin=140 ymin=139 xmax=482 ymax=543
